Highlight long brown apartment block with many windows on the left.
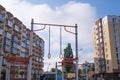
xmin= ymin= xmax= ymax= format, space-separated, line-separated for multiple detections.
xmin=0 ymin=5 xmax=44 ymax=80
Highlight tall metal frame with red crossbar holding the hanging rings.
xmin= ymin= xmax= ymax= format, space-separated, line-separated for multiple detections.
xmin=29 ymin=19 xmax=78 ymax=80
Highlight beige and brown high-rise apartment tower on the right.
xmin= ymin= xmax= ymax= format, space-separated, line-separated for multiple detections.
xmin=92 ymin=15 xmax=120 ymax=80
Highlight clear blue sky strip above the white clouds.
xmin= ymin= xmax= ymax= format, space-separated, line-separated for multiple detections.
xmin=27 ymin=0 xmax=120 ymax=18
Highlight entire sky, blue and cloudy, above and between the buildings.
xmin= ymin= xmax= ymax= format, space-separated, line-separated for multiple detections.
xmin=0 ymin=0 xmax=120 ymax=71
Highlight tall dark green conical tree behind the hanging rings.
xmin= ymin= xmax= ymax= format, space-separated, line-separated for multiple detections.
xmin=64 ymin=43 xmax=73 ymax=73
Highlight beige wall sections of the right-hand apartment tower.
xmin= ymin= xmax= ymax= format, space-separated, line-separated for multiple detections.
xmin=92 ymin=16 xmax=120 ymax=73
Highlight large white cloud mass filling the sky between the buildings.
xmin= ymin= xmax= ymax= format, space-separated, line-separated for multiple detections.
xmin=0 ymin=0 xmax=96 ymax=70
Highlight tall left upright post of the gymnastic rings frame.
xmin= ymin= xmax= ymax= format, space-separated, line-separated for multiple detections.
xmin=27 ymin=19 xmax=34 ymax=80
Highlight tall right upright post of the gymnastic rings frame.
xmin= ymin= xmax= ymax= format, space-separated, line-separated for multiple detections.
xmin=75 ymin=24 xmax=78 ymax=80
